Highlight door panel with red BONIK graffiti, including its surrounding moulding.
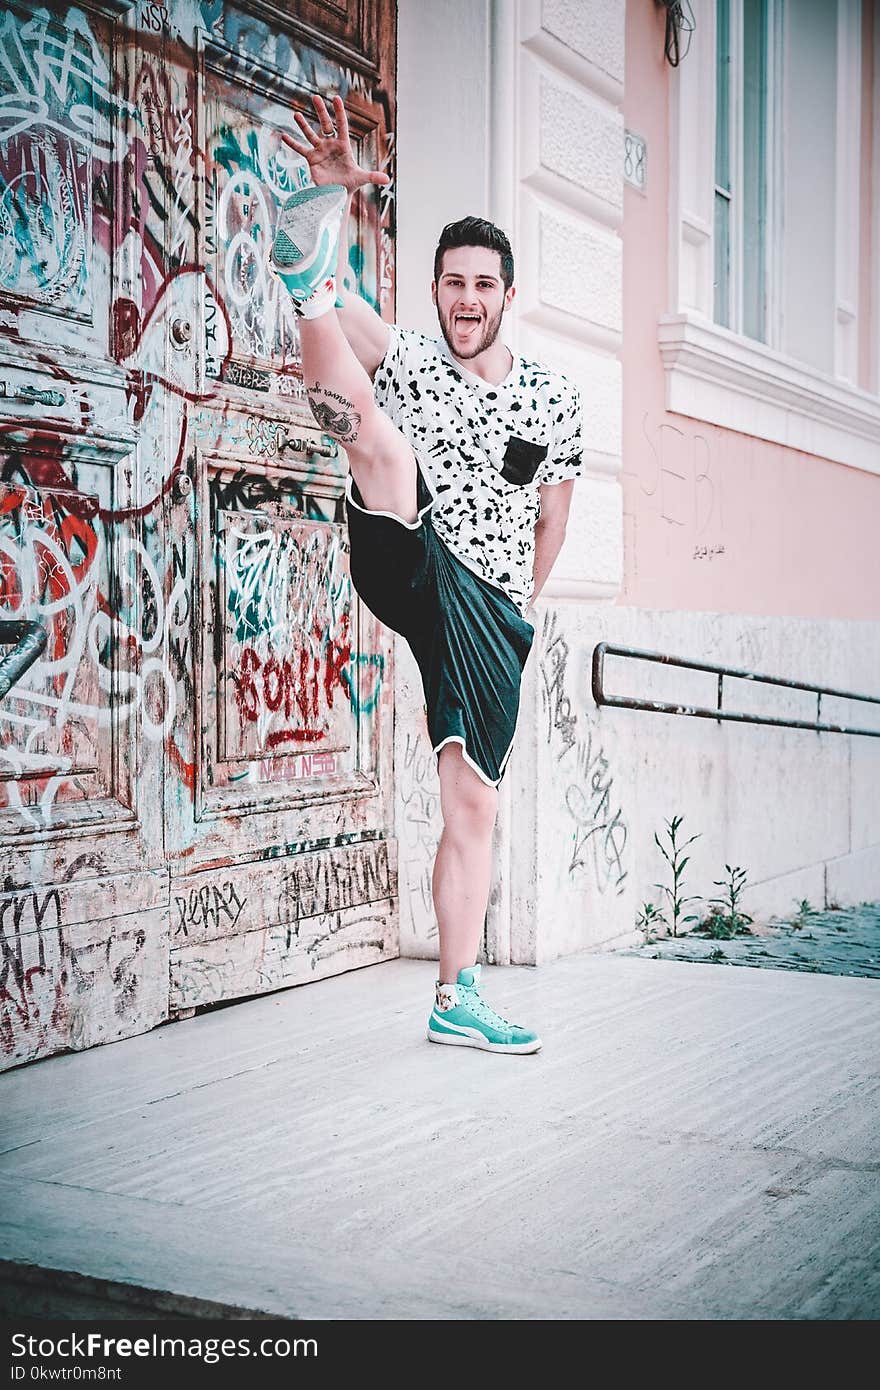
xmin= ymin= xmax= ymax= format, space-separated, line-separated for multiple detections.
xmin=178 ymin=432 xmax=392 ymax=872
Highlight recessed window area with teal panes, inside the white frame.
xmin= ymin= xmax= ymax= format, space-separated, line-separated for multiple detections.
xmin=712 ymin=0 xmax=859 ymax=374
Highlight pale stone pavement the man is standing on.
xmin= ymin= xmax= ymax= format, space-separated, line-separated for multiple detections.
xmin=0 ymin=955 xmax=880 ymax=1319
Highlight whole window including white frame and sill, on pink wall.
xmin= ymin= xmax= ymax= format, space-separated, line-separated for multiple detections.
xmin=659 ymin=0 xmax=880 ymax=473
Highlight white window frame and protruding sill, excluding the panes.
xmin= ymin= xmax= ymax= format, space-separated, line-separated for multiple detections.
xmin=659 ymin=0 xmax=880 ymax=474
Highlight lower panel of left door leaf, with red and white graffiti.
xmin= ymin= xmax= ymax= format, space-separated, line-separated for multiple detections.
xmin=0 ymin=431 xmax=139 ymax=848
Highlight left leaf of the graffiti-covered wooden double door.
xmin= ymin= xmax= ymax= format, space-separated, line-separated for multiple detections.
xmin=0 ymin=0 xmax=170 ymax=1065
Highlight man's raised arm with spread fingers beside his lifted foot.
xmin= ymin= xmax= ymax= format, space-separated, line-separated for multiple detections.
xmin=284 ymin=96 xmax=391 ymax=377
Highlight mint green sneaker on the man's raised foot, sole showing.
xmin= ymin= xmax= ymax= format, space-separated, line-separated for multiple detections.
xmin=268 ymin=183 xmax=348 ymax=318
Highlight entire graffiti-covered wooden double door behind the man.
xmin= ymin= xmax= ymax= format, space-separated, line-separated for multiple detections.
xmin=0 ymin=0 xmax=398 ymax=1065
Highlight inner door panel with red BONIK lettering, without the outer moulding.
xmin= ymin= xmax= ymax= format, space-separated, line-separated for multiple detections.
xmin=203 ymin=464 xmax=385 ymax=805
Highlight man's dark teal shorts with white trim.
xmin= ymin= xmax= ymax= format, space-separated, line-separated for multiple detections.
xmin=346 ymin=473 xmax=535 ymax=787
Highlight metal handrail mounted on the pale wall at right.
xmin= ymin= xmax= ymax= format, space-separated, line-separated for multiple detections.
xmin=592 ymin=642 xmax=880 ymax=738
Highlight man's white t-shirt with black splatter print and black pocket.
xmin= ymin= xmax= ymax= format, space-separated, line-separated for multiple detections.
xmin=374 ymin=328 xmax=584 ymax=613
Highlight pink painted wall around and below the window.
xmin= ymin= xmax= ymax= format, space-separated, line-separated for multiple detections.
xmin=617 ymin=0 xmax=880 ymax=619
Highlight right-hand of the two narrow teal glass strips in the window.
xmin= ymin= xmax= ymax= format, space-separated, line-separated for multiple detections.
xmin=742 ymin=0 xmax=767 ymax=341
